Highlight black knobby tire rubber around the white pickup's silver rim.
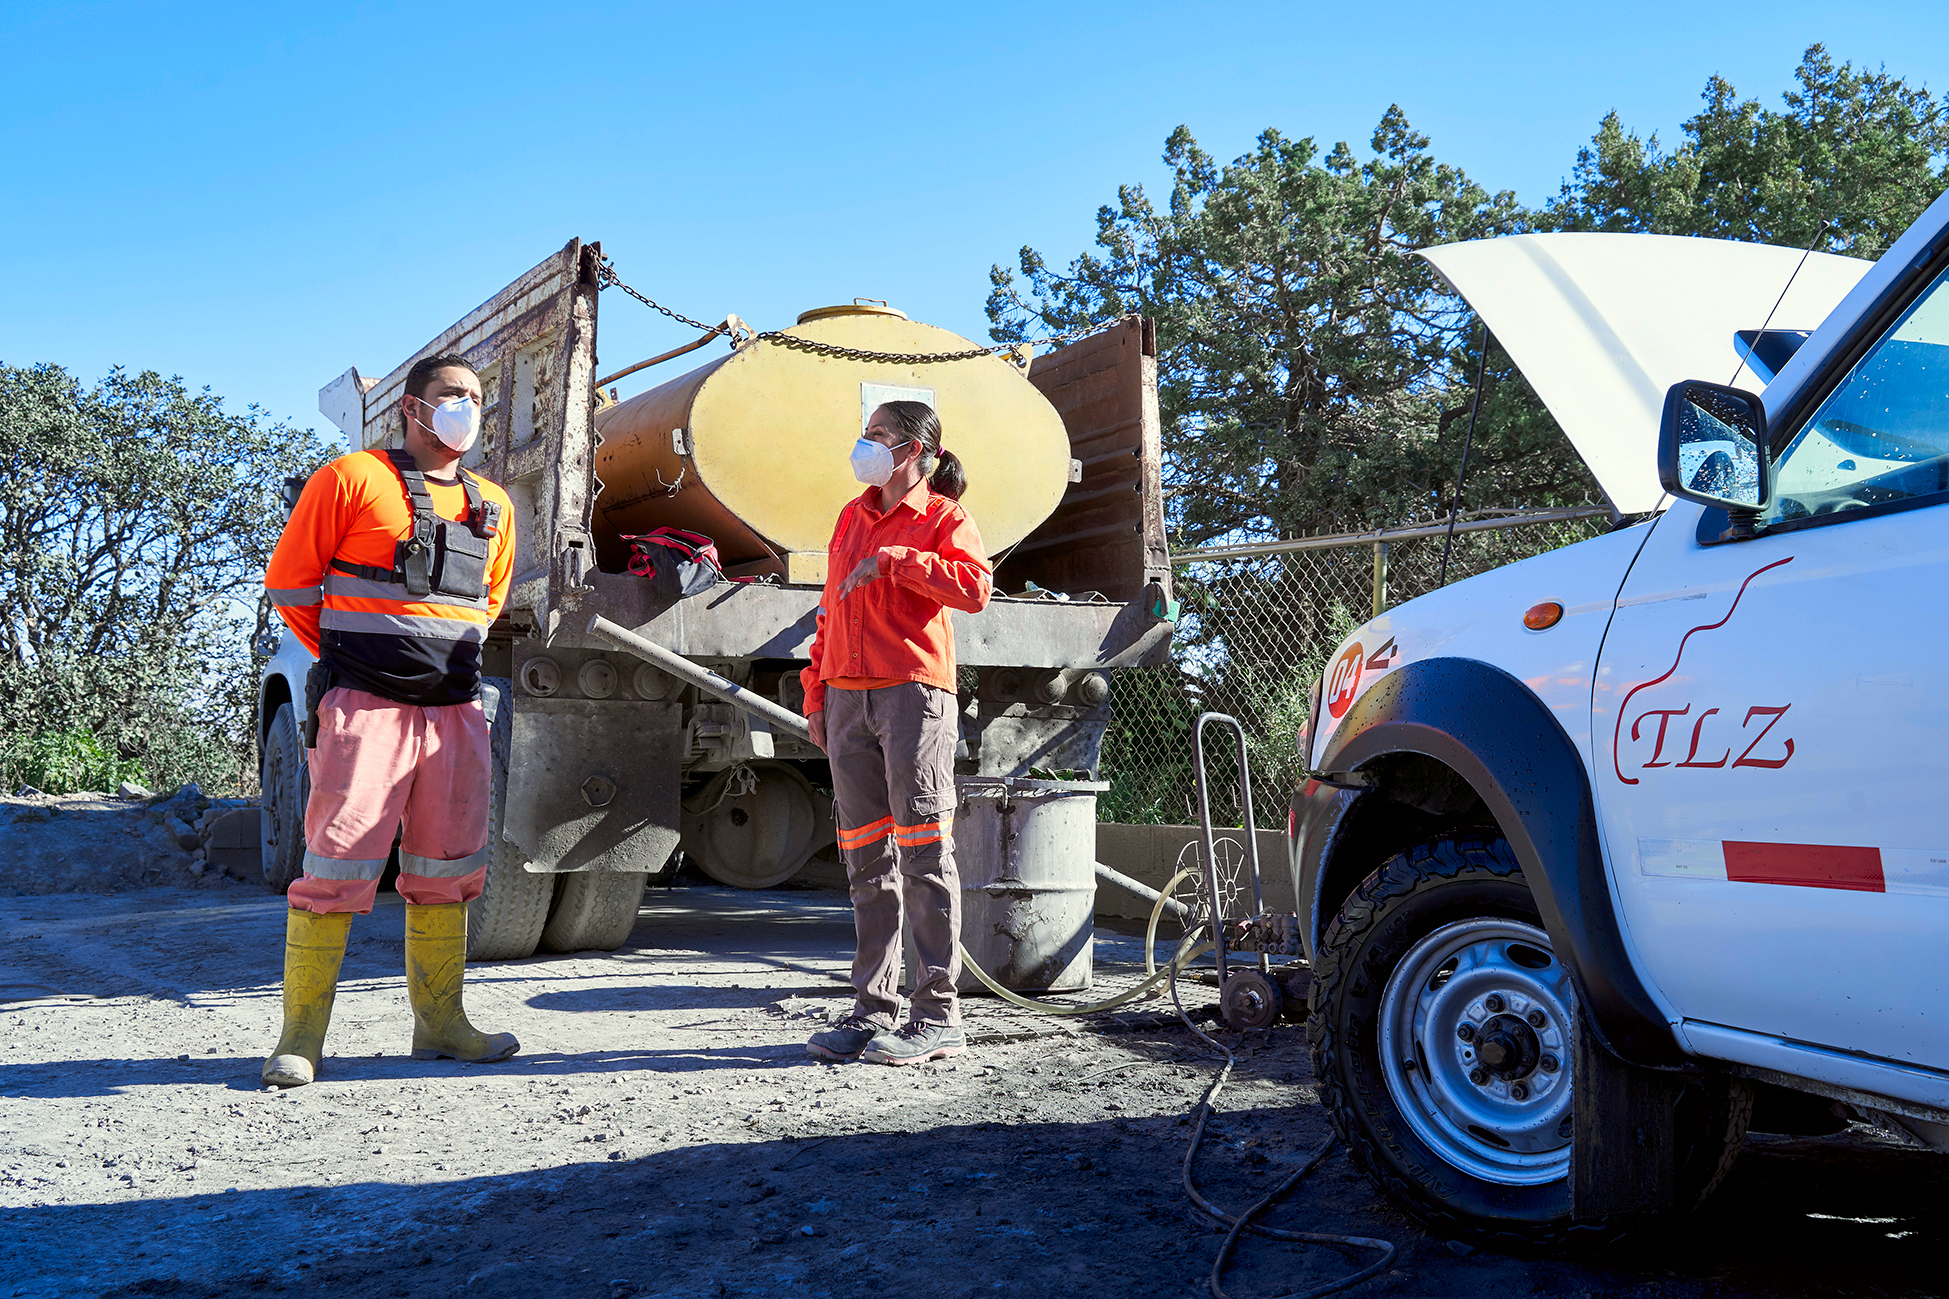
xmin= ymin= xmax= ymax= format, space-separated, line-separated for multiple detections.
xmin=1306 ymin=833 xmax=1752 ymax=1250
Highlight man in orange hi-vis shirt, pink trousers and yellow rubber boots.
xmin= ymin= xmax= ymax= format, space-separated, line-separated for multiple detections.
xmin=263 ymin=357 xmax=518 ymax=1086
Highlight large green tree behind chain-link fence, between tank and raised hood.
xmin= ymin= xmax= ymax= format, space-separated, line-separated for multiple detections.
xmin=988 ymin=107 xmax=1592 ymax=548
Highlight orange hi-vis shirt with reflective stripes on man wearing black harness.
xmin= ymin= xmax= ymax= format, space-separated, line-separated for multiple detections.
xmin=263 ymin=451 xmax=515 ymax=706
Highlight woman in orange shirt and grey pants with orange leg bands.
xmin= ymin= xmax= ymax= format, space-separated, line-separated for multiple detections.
xmin=803 ymin=402 xmax=992 ymax=1065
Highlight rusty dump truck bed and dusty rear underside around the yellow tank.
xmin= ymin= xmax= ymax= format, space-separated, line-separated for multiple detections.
xmin=294 ymin=240 xmax=1173 ymax=946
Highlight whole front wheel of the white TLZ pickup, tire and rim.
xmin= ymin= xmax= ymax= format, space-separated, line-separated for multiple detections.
xmin=1306 ymin=833 xmax=1752 ymax=1248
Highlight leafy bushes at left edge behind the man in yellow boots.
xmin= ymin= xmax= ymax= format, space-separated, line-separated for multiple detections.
xmin=0 ymin=365 xmax=329 ymax=788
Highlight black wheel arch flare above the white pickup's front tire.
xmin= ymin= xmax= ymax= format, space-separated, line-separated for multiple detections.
xmin=1294 ymin=657 xmax=1696 ymax=1069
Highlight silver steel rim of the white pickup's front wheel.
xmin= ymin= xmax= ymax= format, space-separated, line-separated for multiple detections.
xmin=1378 ymin=917 xmax=1575 ymax=1186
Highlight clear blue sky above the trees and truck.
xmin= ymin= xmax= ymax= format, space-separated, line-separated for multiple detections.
xmin=0 ymin=0 xmax=1949 ymax=442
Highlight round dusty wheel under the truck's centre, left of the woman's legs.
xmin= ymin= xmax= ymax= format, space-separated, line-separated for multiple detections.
xmin=686 ymin=763 xmax=819 ymax=889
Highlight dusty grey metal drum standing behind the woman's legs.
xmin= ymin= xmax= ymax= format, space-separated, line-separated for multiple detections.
xmin=906 ymin=776 xmax=1109 ymax=993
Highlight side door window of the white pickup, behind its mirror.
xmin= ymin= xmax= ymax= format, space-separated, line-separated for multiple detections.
xmin=1764 ymin=261 xmax=1949 ymax=523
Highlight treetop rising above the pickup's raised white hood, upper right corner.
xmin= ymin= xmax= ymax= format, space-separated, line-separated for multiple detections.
xmin=1544 ymin=45 xmax=1949 ymax=257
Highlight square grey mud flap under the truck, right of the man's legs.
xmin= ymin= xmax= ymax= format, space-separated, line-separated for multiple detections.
xmin=501 ymin=694 xmax=684 ymax=872
